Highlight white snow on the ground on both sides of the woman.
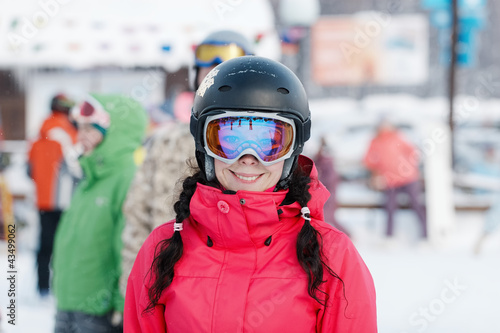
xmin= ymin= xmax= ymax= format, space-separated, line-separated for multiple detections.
xmin=0 ymin=209 xmax=500 ymax=333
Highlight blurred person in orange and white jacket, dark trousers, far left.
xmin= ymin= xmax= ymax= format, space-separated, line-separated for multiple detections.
xmin=28 ymin=94 xmax=81 ymax=296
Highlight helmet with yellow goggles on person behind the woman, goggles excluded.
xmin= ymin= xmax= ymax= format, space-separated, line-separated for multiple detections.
xmin=190 ymin=30 xmax=254 ymax=90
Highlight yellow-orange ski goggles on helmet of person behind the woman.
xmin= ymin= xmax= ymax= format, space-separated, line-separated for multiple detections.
xmin=195 ymin=43 xmax=246 ymax=67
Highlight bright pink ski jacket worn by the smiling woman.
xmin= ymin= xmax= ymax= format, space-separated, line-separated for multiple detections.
xmin=124 ymin=156 xmax=377 ymax=333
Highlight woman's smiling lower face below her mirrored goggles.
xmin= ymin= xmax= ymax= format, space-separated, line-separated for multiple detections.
xmin=214 ymin=154 xmax=285 ymax=192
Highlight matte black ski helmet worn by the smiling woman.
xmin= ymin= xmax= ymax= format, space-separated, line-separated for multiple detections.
xmin=190 ymin=56 xmax=311 ymax=188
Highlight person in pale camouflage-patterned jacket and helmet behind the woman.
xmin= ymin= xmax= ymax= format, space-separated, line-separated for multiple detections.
xmin=120 ymin=30 xmax=253 ymax=295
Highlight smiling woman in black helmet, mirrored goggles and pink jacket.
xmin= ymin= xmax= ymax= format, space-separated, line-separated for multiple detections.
xmin=124 ymin=56 xmax=377 ymax=333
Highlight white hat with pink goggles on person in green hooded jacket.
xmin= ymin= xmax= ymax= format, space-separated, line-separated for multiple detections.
xmin=72 ymin=97 xmax=110 ymax=135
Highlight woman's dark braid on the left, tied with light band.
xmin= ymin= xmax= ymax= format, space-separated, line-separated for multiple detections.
xmin=144 ymin=170 xmax=212 ymax=312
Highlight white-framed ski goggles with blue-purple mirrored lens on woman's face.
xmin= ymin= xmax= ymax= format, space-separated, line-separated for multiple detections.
xmin=203 ymin=111 xmax=296 ymax=166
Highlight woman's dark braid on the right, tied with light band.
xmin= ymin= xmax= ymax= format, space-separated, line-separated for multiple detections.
xmin=292 ymin=167 xmax=344 ymax=306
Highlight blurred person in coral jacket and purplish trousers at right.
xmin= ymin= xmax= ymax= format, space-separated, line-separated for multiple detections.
xmin=363 ymin=117 xmax=427 ymax=239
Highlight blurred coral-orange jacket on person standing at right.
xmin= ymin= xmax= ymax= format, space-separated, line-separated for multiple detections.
xmin=363 ymin=131 xmax=420 ymax=188
